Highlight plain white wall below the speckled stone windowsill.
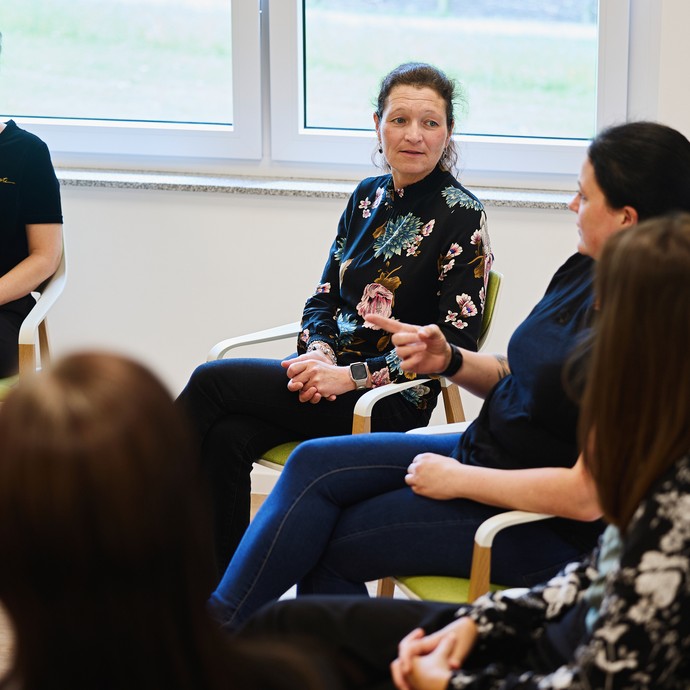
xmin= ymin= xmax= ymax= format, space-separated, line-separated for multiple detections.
xmin=50 ymin=187 xmax=576 ymax=408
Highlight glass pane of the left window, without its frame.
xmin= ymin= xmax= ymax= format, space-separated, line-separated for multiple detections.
xmin=2 ymin=0 xmax=232 ymax=125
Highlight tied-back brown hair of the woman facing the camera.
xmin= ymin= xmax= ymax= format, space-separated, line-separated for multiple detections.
xmin=376 ymin=62 xmax=458 ymax=170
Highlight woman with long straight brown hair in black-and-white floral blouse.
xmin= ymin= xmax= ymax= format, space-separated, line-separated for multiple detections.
xmin=239 ymin=213 xmax=690 ymax=690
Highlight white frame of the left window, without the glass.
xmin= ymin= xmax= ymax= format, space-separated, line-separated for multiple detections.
xmin=7 ymin=0 xmax=262 ymax=168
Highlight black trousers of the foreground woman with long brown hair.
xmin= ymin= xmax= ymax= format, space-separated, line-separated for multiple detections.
xmin=237 ymin=596 xmax=568 ymax=690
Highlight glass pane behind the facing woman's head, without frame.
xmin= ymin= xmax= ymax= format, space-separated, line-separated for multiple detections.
xmin=302 ymin=0 xmax=598 ymax=139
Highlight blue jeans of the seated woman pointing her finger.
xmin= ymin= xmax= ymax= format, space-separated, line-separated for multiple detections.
xmin=210 ymin=433 xmax=595 ymax=628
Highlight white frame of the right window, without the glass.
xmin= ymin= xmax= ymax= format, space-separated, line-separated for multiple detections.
xmin=269 ymin=0 xmax=630 ymax=187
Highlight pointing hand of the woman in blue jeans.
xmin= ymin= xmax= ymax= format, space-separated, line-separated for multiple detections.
xmin=364 ymin=314 xmax=451 ymax=374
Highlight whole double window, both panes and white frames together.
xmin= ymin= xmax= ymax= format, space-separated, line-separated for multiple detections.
xmin=0 ymin=0 xmax=630 ymax=186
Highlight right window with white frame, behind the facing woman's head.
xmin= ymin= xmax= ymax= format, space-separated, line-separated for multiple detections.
xmin=271 ymin=0 xmax=629 ymax=184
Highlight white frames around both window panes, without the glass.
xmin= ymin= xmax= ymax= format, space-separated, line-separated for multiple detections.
xmin=4 ymin=0 xmax=633 ymax=189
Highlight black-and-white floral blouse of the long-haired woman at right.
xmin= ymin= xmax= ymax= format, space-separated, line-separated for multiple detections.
xmin=449 ymin=456 xmax=690 ymax=690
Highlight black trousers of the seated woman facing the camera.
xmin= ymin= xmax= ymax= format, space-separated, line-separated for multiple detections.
xmin=177 ymin=358 xmax=433 ymax=578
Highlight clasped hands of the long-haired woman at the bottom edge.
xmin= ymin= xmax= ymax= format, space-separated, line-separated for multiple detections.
xmin=391 ymin=617 xmax=477 ymax=690
